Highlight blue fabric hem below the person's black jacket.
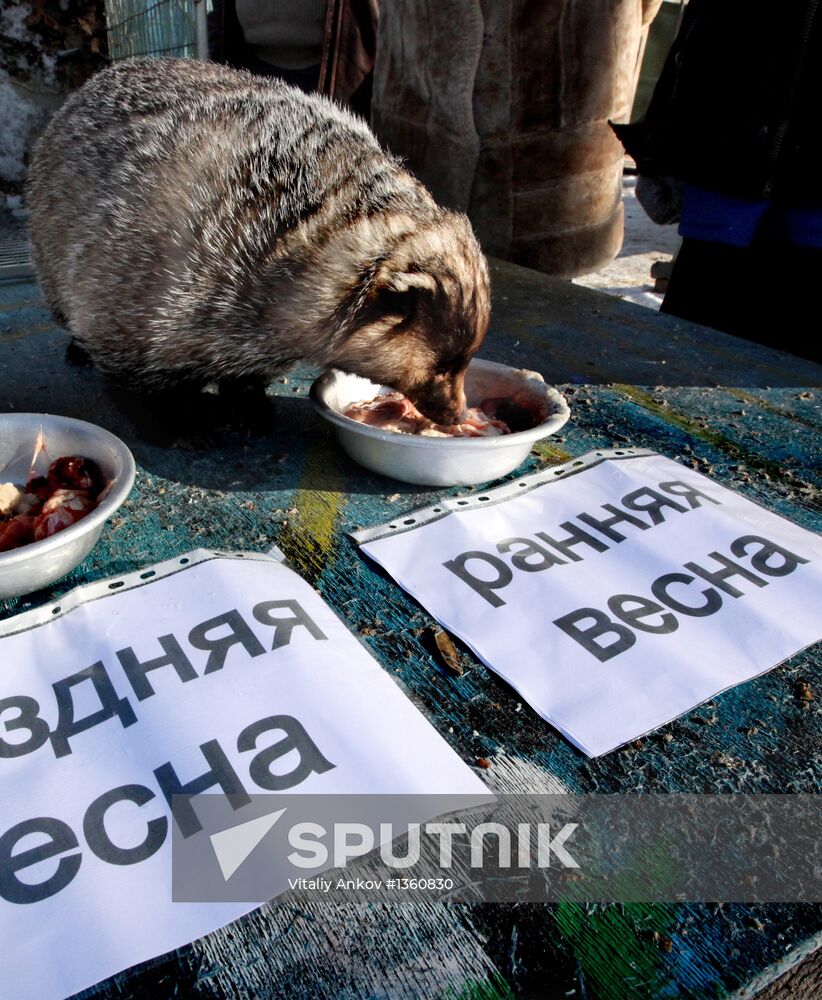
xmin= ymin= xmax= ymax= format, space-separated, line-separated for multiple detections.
xmin=679 ymin=184 xmax=822 ymax=248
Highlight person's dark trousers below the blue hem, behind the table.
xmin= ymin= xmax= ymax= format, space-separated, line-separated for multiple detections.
xmin=661 ymin=236 xmax=822 ymax=362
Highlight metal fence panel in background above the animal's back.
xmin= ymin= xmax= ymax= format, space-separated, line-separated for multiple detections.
xmin=105 ymin=0 xmax=208 ymax=61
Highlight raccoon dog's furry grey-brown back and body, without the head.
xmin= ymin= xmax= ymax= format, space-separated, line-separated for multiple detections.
xmin=28 ymin=59 xmax=440 ymax=384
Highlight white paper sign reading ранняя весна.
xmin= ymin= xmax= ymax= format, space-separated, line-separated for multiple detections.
xmin=355 ymin=451 xmax=822 ymax=757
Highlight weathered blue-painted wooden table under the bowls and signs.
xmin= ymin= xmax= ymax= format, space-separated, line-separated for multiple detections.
xmin=0 ymin=263 xmax=822 ymax=1000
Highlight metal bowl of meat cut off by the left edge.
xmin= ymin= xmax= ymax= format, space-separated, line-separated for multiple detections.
xmin=0 ymin=413 xmax=135 ymax=598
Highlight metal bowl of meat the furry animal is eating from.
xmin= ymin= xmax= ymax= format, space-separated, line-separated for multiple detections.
xmin=311 ymin=358 xmax=571 ymax=486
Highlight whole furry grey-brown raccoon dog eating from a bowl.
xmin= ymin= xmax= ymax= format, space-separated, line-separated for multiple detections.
xmin=27 ymin=59 xmax=490 ymax=423
